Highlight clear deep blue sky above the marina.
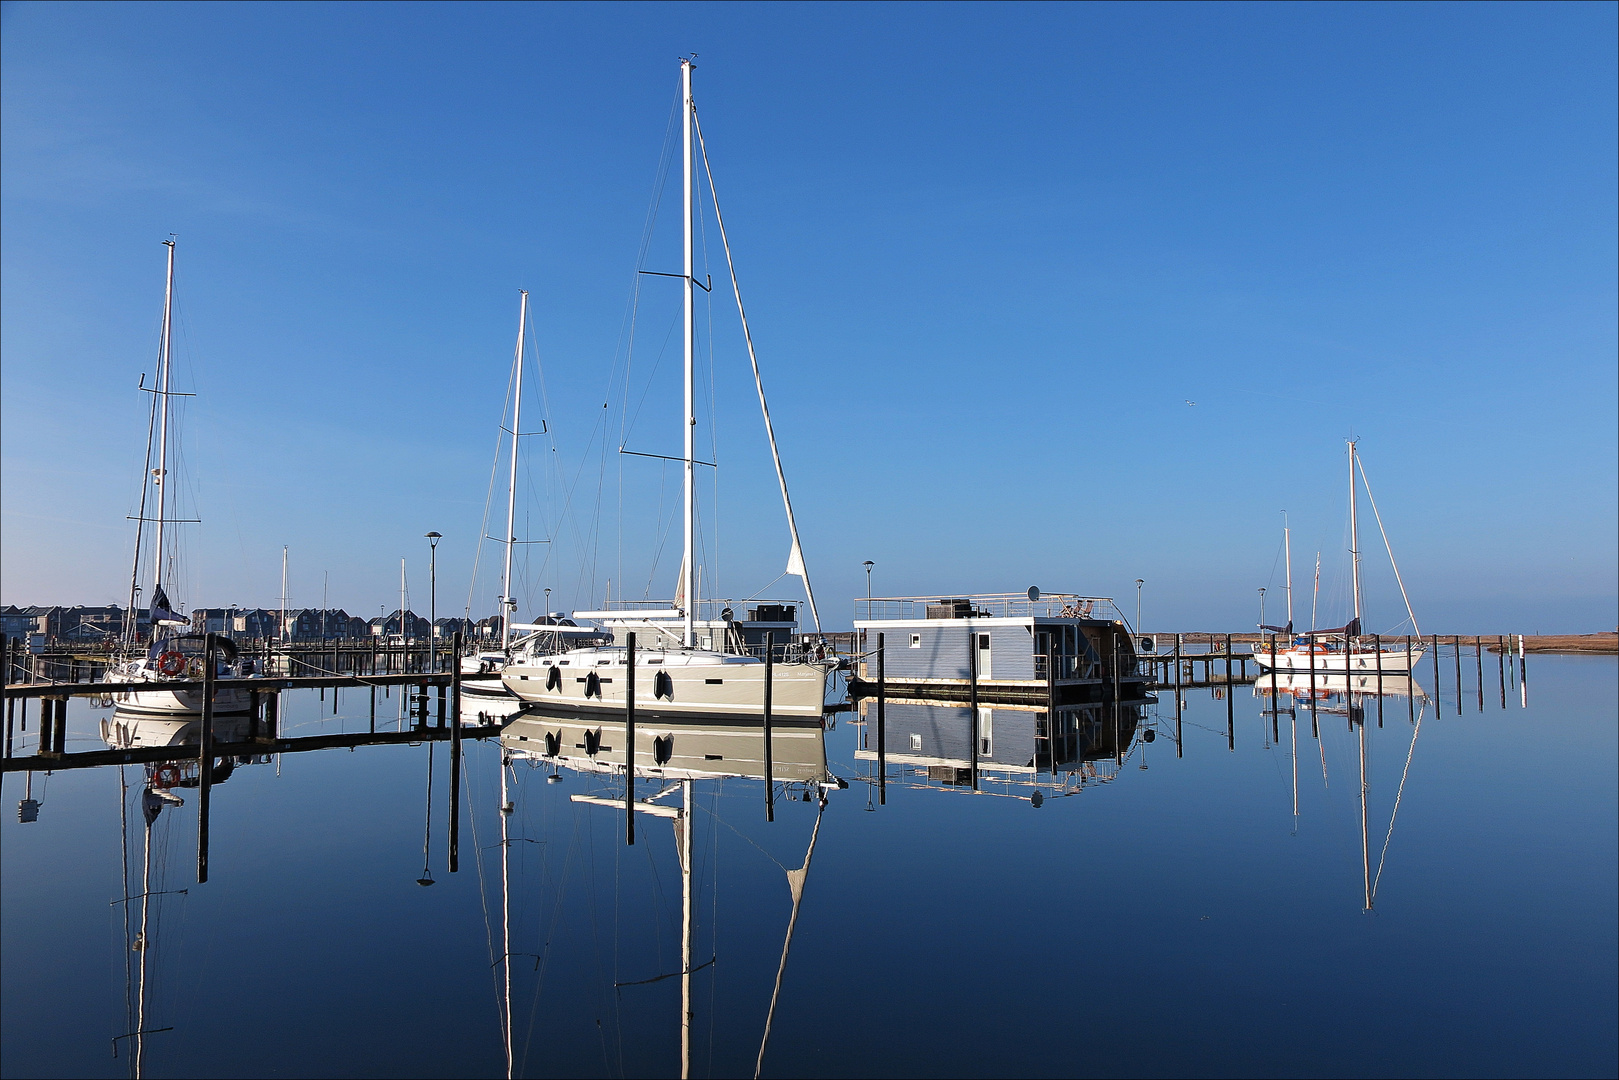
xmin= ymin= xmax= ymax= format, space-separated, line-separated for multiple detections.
xmin=0 ymin=3 xmax=1619 ymax=633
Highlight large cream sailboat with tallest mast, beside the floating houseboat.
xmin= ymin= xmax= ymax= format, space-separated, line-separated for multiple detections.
xmin=502 ymin=58 xmax=835 ymax=717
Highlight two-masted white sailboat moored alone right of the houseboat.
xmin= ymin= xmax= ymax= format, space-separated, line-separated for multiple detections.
xmin=1253 ymin=439 xmax=1423 ymax=675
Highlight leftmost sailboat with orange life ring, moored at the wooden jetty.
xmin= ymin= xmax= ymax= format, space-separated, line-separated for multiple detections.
xmin=108 ymin=240 xmax=249 ymax=717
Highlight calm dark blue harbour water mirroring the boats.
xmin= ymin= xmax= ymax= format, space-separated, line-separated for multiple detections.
xmin=0 ymin=657 xmax=1619 ymax=1077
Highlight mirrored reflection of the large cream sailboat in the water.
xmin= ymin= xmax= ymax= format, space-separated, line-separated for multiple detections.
xmin=491 ymin=708 xmax=848 ymax=1077
